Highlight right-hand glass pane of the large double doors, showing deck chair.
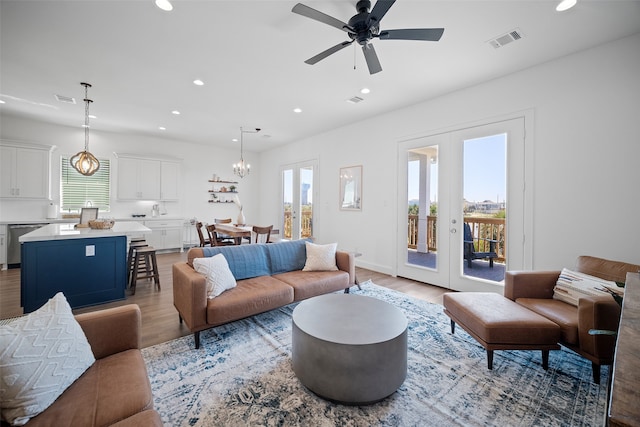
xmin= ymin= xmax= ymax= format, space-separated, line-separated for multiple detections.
xmin=460 ymin=134 xmax=507 ymax=282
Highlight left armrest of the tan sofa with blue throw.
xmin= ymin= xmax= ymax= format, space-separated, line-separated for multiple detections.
xmin=172 ymin=262 xmax=207 ymax=332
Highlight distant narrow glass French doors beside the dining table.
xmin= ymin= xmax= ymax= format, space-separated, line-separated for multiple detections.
xmin=280 ymin=160 xmax=317 ymax=240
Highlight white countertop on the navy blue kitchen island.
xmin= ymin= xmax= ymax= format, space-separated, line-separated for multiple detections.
xmin=20 ymin=221 xmax=151 ymax=243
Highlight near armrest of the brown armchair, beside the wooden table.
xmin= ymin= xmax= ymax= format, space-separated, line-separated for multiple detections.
xmin=578 ymin=295 xmax=621 ymax=360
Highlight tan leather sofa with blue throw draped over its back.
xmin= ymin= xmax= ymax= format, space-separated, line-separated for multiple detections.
xmin=173 ymin=241 xmax=355 ymax=348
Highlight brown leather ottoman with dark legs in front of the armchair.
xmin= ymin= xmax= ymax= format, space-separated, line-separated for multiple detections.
xmin=443 ymin=292 xmax=560 ymax=370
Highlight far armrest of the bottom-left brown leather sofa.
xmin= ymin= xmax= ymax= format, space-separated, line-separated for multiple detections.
xmin=75 ymin=304 xmax=142 ymax=359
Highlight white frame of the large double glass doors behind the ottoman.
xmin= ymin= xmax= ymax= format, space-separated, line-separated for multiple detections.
xmin=394 ymin=109 xmax=534 ymax=292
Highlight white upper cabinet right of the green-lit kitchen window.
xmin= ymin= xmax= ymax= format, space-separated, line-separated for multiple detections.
xmin=117 ymin=154 xmax=180 ymax=201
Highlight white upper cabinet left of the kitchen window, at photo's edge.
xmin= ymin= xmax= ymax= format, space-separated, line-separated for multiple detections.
xmin=0 ymin=142 xmax=54 ymax=199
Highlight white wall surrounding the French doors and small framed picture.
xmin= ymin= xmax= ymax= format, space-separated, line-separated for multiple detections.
xmin=260 ymin=34 xmax=640 ymax=274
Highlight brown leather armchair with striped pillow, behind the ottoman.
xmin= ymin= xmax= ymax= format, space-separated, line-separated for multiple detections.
xmin=504 ymin=256 xmax=640 ymax=384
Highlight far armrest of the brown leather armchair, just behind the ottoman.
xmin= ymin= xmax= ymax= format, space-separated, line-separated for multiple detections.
xmin=504 ymin=271 xmax=560 ymax=301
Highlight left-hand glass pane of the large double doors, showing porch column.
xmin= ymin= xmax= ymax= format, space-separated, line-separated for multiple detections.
xmin=407 ymin=145 xmax=438 ymax=269
